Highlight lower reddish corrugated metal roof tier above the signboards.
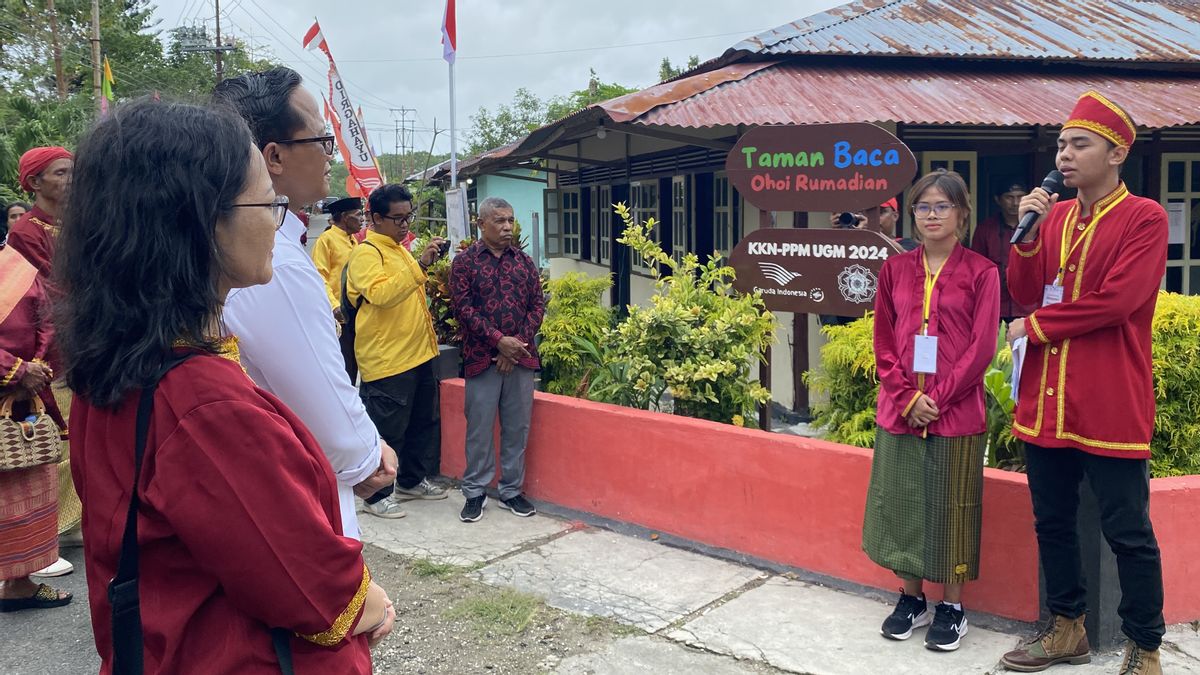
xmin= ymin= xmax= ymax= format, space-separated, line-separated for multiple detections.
xmin=643 ymin=61 xmax=1200 ymax=129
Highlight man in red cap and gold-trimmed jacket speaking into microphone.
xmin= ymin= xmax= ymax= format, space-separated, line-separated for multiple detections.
xmin=1001 ymin=91 xmax=1166 ymax=675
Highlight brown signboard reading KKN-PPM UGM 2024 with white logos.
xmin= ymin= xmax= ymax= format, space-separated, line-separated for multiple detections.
xmin=730 ymin=228 xmax=904 ymax=316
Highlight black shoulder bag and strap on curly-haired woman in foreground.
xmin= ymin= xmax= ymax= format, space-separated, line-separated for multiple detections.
xmin=108 ymin=354 xmax=293 ymax=675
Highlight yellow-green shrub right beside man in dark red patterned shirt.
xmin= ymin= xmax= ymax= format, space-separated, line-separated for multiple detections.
xmin=538 ymin=273 xmax=612 ymax=396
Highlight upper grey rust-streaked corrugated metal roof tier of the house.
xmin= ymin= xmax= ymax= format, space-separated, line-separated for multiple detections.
xmin=721 ymin=0 xmax=1200 ymax=64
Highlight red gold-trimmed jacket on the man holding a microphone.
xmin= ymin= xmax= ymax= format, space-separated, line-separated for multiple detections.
xmin=1008 ymin=184 xmax=1168 ymax=459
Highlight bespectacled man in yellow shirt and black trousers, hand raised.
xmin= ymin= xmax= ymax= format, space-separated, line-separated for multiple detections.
xmin=346 ymin=184 xmax=446 ymax=518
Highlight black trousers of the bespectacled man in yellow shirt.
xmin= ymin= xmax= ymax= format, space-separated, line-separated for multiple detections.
xmin=359 ymin=360 xmax=442 ymax=504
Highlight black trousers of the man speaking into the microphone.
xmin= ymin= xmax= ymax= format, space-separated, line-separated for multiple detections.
xmin=1025 ymin=443 xmax=1166 ymax=650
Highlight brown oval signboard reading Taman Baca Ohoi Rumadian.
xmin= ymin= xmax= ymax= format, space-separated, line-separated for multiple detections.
xmin=725 ymin=123 xmax=917 ymax=213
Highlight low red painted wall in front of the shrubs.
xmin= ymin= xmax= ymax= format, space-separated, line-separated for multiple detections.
xmin=442 ymin=380 xmax=1200 ymax=623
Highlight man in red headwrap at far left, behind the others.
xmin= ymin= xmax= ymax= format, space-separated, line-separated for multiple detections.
xmin=8 ymin=147 xmax=74 ymax=280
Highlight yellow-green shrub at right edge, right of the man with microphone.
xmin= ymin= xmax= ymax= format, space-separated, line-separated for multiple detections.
xmin=1150 ymin=292 xmax=1200 ymax=476
